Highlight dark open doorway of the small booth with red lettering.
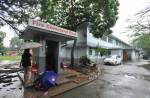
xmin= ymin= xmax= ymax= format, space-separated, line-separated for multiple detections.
xmin=46 ymin=40 xmax=59 ymax=73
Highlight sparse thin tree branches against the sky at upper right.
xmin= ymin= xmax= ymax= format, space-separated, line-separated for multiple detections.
xmin=128 ymin=2 xmax=150 ymax=36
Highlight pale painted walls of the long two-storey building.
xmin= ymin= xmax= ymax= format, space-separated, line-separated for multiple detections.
xmin=62 ymin=24 xmax=141 ymax=62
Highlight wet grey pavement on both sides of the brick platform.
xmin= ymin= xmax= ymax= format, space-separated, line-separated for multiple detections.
xmin=0 ymin=61 xmax=150 ymax=98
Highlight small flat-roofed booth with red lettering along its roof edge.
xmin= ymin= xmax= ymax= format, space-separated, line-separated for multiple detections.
xmin=20 ymin=19 xmax=77 ymax=73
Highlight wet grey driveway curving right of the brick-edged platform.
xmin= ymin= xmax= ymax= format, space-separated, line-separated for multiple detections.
xmin=54 ymin=61 xmax=150 ymax=98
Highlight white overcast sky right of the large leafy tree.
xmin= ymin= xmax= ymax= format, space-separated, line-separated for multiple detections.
xmin=113 ymin=0 xmax=150 ymax=43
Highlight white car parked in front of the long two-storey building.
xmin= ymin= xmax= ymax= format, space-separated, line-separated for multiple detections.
xmin=104 ymin=55 xmax=122 ymax=65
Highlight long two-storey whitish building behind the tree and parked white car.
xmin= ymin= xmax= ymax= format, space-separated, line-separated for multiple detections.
xmin=61 ymin=23 xmax=140 ymax=63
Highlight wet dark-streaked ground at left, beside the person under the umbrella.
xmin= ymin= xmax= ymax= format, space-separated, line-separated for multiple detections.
xmin=0 ymin=61 xmax=24 ymax=98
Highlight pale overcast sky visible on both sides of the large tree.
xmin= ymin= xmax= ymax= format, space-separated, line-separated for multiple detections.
xmin=0 ymin=0 xmax=150 ymax=46
